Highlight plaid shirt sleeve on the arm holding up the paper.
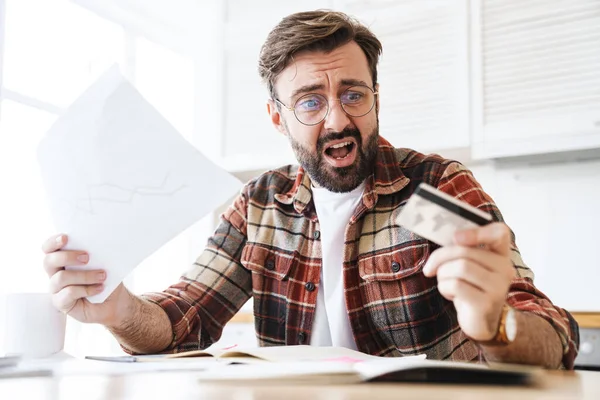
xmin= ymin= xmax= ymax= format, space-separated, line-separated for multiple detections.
xmin=132 ymin=190 xmax=252 ymax=353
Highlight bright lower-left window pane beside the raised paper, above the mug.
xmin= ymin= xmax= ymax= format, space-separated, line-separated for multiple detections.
xmin=0 ymin=99 xmax=57 ymax=292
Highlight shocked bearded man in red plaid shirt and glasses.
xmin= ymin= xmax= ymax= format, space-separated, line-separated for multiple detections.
xmin=43 ymin=11 xmax=579 ymax=368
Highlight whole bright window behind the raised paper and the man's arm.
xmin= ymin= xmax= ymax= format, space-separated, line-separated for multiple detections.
xmin=0 ymin=0 xmax=213 ymax=355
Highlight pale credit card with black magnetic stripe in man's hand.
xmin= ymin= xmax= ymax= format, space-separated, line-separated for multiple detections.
xmin=397 ymin=183 xmax=493 ymax=246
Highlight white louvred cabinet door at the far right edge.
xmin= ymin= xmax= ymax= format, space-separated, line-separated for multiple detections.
xmin=471 ymin=0 xmax=600 ymax=159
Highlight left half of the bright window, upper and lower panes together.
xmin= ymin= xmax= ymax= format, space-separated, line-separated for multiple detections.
xmin=0 ymin=0 xmax=125 ymax=291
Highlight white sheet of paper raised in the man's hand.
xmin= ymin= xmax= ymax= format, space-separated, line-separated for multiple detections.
xmin=38 ymin=66 xmax=241 ymax=303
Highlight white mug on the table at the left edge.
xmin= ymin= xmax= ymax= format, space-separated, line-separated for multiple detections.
xmin=0 ymin=293 xmax=67 ymax=358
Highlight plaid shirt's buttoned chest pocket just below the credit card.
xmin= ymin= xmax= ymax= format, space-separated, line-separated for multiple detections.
xmin=358 ymin=240 xmax=444 ymax=331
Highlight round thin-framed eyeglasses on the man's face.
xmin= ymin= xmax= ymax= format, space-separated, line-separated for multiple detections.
xmin=275 ymin=85 xmax=378 ymax=126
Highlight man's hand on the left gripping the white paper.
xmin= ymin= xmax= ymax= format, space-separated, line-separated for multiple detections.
xmin=42 ymin=234 xmax=133 ymax=327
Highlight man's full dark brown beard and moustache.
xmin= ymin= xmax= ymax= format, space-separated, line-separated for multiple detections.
xmin=286 ymin=124 xmax=379 ymax=193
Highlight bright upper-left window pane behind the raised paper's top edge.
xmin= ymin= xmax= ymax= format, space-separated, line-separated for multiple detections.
xmin=3 ymin=0 xmax=125 ymax=108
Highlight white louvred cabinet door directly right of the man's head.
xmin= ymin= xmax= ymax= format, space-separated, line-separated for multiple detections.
xmin=343 ymin=0 xmax=470 ymax=159
